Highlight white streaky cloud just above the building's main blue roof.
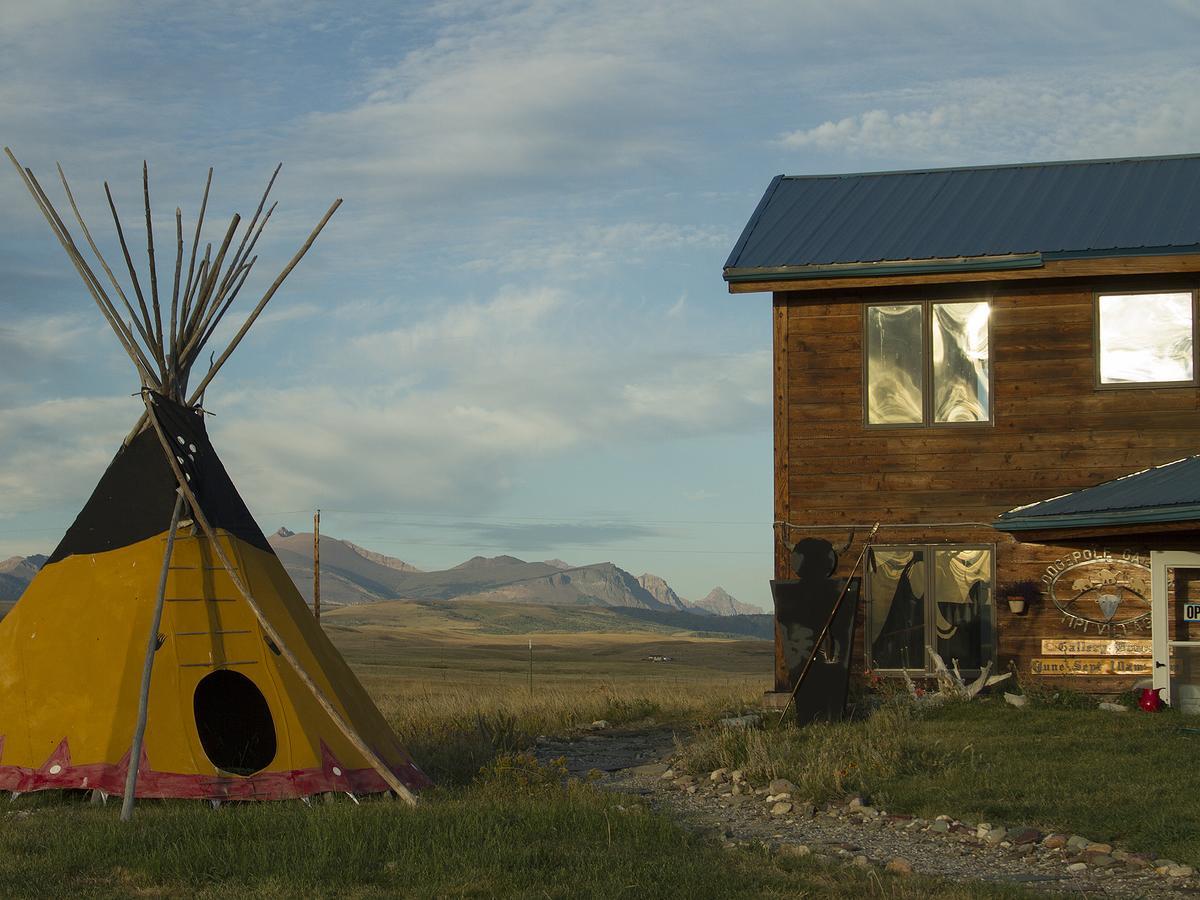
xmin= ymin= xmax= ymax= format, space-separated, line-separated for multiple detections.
xmin=778 ymin=66 xmax=1200 ymax=164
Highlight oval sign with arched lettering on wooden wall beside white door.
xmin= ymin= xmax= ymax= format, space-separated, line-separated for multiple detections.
xmin=1042 ymin=550 xmax=1150 ymax=633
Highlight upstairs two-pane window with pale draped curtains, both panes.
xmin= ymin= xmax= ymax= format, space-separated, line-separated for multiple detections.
xmin=865 ymin=301 xmax=991 ymax=425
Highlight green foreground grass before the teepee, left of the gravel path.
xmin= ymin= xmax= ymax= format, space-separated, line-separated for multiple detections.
xmin=0 ymin=760 xmax=1027 ymax=900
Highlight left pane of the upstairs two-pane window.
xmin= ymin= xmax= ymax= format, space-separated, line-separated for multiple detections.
xmin=866 ymin=304 xmax=924 ymax=425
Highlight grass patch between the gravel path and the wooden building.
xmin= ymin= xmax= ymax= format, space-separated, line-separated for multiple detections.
xmin=684 ymin=697 xmax=1200 ymax=864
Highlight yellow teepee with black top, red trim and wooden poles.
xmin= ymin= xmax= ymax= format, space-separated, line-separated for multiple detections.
xmin=0 ymin=148 xmax=428 ymax=817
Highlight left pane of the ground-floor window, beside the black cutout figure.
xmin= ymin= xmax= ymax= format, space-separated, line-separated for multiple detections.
xmin=866 ymin=550 xmax=925 ymax=670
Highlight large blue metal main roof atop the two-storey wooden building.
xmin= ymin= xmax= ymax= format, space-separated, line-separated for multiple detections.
xmin=725 ymin=155 xmax=1200 ymax=281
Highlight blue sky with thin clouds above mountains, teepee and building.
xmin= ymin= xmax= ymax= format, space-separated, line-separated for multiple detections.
xmin=0 ymin=0 xmax=1200 ymax=608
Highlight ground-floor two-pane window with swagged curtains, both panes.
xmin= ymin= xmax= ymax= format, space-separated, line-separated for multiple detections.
xmin=866 ymin=545 xmax=996 ymax=672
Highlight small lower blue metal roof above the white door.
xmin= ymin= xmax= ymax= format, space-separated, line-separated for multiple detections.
xmin=995 ymin=456 xmax=1200 ymax=532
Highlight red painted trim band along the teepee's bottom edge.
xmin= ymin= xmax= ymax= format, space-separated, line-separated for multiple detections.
xmin=0 ymin=737 xmax=433 ymax=800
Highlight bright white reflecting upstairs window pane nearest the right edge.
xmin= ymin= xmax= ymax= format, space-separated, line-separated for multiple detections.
xmin=1098 ymin=293 xmax=1192 ymax=384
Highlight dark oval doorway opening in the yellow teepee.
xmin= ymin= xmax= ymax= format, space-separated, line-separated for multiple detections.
xmin=192 ymin=668 xmax=276 ymax=775
